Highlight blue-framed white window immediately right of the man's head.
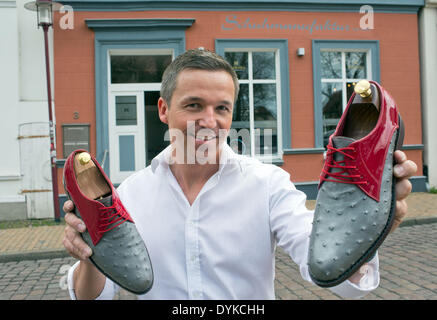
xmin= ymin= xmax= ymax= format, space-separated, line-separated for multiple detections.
xmin=215 ymin=39 xmax=291 ymax=162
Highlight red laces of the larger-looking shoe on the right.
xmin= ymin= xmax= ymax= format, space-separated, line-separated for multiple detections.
xmin=321 ymin=145 xmax=367 ymax=184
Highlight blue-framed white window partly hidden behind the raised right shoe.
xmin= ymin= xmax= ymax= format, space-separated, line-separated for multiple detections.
xmin=313 ymin=40 xmax=379 ymax=148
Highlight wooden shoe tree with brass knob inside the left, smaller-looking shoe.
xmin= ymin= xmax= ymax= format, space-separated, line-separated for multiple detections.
xmin=74 ymin=152 xmax=111 ymax=200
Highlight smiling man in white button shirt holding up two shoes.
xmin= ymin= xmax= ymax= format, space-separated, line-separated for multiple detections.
xmin=64 ymin=50 xmax=416 ymax=299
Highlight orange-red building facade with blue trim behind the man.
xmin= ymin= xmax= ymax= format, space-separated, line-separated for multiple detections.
xmin=0 ymin=0 xmax=426 ymax=220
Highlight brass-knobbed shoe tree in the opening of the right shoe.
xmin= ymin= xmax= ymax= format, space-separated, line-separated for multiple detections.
xmin=343 ymin=80 xmax=380 ymax=140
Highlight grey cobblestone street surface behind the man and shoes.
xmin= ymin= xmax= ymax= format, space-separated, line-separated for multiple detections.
xmin=0 ymin=223 xmax=437 ymax=300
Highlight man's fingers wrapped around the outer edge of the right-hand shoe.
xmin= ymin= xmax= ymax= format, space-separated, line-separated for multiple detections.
xmin=390 ymin=150 xmax=417 ymax=232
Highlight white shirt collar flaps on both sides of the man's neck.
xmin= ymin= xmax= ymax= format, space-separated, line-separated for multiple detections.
xmin=151 ymin=143 xmax=243 ymax=174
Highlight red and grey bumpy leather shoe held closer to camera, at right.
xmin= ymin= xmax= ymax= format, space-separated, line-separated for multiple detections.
xmin=308 ymin=80 xmax=404 ymax=287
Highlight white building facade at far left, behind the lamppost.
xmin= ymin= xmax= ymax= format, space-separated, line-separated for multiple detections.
xmin=0 ymin=0 xmax=54 ymax=220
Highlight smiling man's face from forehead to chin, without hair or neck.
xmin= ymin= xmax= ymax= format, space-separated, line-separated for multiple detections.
xmin=158 ymin=70 xmax=235 ymax=161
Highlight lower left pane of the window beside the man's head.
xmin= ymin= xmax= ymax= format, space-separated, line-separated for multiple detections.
xmin=228 ymin=84 xmax=251 ymax=155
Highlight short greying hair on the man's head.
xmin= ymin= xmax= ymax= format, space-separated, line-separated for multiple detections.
xmin=161 ymin=49 xmax=240 ymax=106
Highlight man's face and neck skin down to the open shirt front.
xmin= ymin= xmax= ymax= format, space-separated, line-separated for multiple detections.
xmin=158 ymin=60 xmax=238 ymax=205
